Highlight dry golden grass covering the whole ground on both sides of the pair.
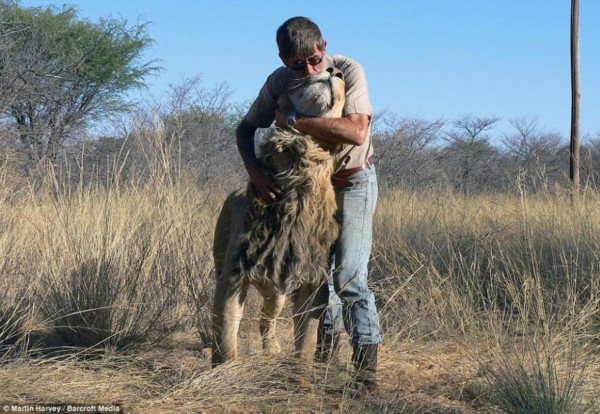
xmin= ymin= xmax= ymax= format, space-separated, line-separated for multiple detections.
xmin=0 ymin=129 xmax=600 ymax=413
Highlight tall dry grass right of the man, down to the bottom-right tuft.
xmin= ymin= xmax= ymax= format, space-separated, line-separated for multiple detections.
xmin=373 ymin=187 xmax=600 ymax=413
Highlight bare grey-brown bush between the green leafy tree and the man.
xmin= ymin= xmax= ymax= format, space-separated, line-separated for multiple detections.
xmin=85 ymin=76 xmax=247 ymax=191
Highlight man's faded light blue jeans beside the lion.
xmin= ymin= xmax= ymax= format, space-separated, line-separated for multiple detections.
xmin=321 ymin=166 xmax=382 ymax=346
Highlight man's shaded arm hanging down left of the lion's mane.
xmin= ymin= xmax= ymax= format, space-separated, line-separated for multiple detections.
xmin=235 ymin=119 xmax=283 ymax=202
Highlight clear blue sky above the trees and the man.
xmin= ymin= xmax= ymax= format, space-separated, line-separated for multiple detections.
xmin=21 ymin=0 xmax=600 ymax=140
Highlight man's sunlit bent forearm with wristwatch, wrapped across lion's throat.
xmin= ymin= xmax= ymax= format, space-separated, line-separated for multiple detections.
xmin=276 ymin=113 xmax=371 ymax=145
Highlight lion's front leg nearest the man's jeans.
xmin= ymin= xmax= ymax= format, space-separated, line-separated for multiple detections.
xmin=294 ymin=285 xmax=327 ymax=364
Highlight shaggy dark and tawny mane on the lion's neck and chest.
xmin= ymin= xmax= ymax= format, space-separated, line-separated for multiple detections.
xmin=241 ymin=124 xmax=338 ymax=293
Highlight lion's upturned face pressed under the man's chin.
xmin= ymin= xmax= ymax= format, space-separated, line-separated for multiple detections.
xmin=288 ymin=71 xmax=345 ymax=117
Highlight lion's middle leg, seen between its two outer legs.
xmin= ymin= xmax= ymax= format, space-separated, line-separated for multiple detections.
xmin=256 ymin=285 xmax=285 ymax=355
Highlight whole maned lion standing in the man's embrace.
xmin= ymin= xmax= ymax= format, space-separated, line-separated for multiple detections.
xmin=212 ymin=71 xmax=345 ymax=366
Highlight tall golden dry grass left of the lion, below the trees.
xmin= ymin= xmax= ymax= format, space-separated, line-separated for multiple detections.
xmin=0 ymin=115 xmax=216 ymax=349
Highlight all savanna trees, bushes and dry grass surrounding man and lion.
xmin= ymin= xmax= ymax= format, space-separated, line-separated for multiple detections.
xmin=0 ymin=1 xmax=600 ymax=413
